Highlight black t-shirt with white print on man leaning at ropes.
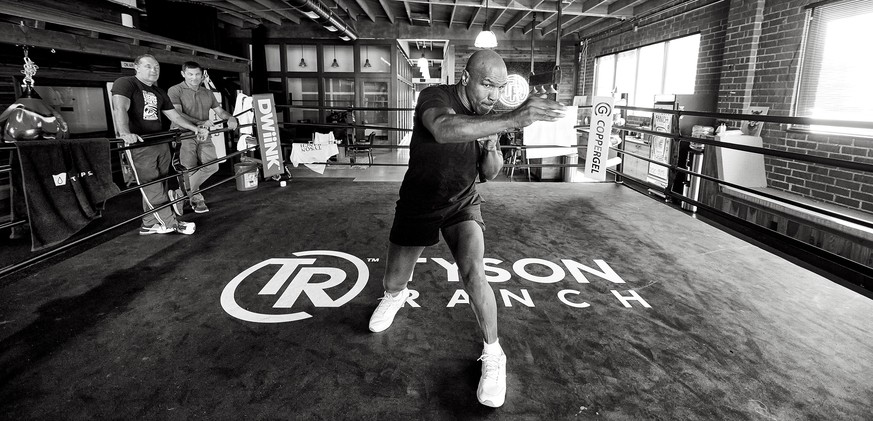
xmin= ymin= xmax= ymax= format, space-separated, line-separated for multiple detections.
xmin=112 ymin=76 xmax=175 ymax=135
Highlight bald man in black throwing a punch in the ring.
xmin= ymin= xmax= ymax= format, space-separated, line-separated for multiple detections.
xmin=370 ymin=50 xmax=564 ymax=407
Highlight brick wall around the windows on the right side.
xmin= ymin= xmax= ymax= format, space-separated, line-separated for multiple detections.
xmin=577 ymin=0 xmax=873 ymax=213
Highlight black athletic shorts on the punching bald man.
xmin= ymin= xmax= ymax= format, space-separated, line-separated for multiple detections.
xmin=389 ymin=195 xmax=485 ymax=247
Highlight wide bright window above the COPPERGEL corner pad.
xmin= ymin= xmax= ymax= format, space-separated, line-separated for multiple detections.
xmin=594 ymin=34 xmax=700 ymax=117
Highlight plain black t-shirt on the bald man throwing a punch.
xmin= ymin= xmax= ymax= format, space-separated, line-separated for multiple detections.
xmin=398 ymin=85 xmax=480 ymax=210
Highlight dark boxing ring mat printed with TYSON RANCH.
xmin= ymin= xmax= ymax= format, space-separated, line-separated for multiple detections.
xmin=0 ymin=180 xmax=873 ymax=420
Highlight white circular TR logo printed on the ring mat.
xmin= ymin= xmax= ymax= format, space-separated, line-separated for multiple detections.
xmin=221 ymin=250 xmax=370 ymax=323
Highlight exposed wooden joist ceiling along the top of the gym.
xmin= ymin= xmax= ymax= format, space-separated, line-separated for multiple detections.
xmin=188 ymin=0 xmax=672 ymax=38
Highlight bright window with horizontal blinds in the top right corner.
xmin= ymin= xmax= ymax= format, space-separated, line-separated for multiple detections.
xmin=794 ymin=0 xmax=873 ymax=136
